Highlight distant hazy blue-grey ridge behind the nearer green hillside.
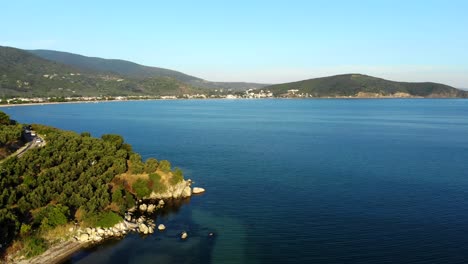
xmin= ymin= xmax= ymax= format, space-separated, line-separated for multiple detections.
xmin=29 ymin=50 xmax=266 ymax=91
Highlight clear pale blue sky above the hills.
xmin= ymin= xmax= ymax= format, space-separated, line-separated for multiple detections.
xmin=0 ymin=0 xmax=468 ymax=88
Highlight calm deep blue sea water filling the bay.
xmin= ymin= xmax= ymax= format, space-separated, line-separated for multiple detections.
xmin=1 ymin=99 xmax=468 ymax=264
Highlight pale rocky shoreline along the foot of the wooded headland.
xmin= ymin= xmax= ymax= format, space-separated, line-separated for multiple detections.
xmin=7 ymin=180 xmax=204 ymax=264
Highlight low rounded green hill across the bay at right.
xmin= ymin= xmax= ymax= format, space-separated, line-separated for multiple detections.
xmin=264 ymin=74 xmax=468 ymax=98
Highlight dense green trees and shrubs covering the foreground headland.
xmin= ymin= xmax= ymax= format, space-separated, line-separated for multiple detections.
xmin=0 ymin=112 xmax=183 ymax=255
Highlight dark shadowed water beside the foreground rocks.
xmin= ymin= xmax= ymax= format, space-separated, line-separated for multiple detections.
xmin=63 ymin=199 xmax=217 ymax=264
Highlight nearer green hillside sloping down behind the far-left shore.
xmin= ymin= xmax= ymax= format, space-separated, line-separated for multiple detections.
xmin=0 ymin=46 xmax=205 ymax=97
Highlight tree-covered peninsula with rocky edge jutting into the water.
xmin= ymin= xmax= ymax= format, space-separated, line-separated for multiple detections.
xmin=0 ymin=112 xmax=192 ymax=261
